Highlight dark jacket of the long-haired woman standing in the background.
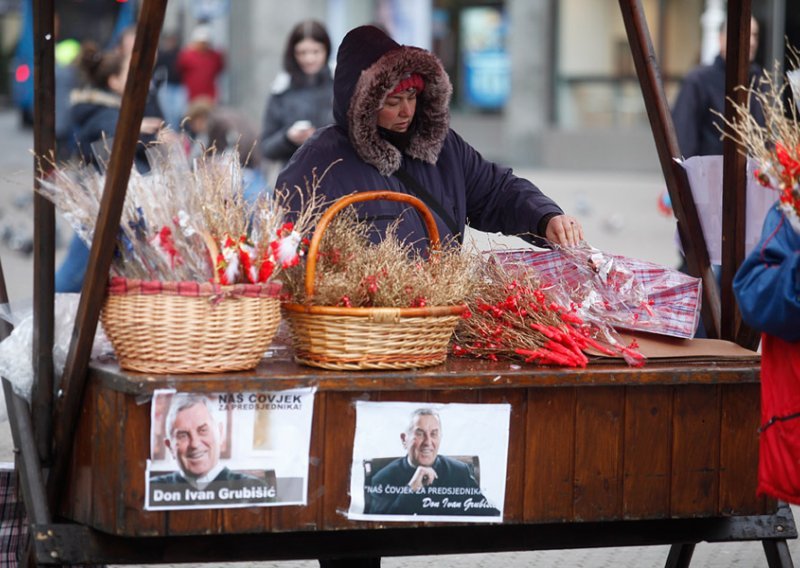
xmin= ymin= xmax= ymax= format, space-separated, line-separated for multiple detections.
xmin=261 ymin=66 xmax=333 ymax=162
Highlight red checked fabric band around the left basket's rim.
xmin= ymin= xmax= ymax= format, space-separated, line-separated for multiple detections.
xmin=108 ymin=276 xmax=283 ymax=299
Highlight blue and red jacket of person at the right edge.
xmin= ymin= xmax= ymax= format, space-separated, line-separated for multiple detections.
xmin=733 ymin=203 xmax=800 ymax=503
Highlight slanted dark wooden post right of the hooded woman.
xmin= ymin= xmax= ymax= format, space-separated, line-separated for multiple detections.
xmin=619 ymin=0 xmax=720 ymax=338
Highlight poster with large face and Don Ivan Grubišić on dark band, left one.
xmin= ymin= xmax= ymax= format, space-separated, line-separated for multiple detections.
xmin=144 ymin=388 xmax=316 ymax=511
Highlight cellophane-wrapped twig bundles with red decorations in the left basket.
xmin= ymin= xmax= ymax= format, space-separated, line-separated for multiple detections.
xmin=34 ymin=131 xmax=322 ymax=284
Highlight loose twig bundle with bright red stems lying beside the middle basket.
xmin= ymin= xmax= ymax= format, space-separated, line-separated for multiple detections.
xmin=453 ymin=255 xmax=644 ymax=367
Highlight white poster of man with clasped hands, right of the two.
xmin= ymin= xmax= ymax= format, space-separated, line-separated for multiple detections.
xmin=347 ymin=401 xmax=511 ymax=523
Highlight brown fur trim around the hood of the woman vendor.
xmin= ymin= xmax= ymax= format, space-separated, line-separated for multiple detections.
xmin=347 ymin=46 xmax=453 ymax=176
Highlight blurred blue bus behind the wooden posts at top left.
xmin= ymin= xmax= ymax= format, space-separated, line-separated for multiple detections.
xmin=11 ymin=0 xmax=137 ymax=125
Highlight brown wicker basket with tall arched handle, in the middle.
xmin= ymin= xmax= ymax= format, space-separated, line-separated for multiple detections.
xmin=283 ymin=191 xmax=465 ymax=371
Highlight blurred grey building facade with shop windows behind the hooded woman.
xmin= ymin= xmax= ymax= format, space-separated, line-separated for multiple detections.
xmin=5 ymin=0 xmax=800 ymax=171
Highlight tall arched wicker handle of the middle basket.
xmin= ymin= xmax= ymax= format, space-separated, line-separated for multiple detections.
xmin=306 ymin=190 xmax=439 ymax=301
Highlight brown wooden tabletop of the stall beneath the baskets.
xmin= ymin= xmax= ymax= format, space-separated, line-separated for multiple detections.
xmin=90 ymin=348 xmax=760 ymax=395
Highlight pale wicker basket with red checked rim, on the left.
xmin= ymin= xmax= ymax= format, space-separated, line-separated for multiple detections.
xmin=101 ymin=277 xmax=281 ymax=374
